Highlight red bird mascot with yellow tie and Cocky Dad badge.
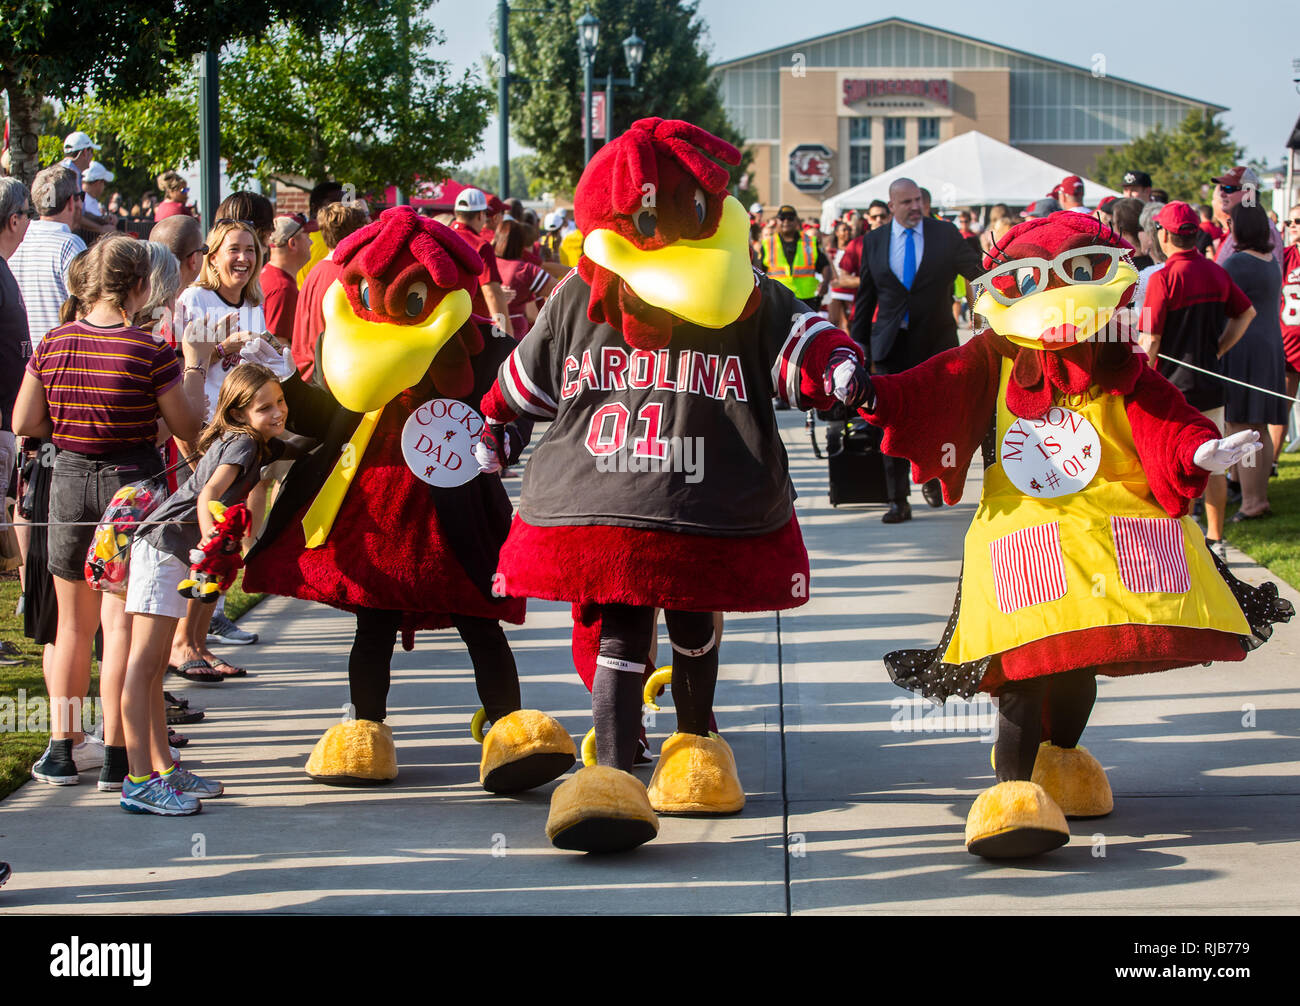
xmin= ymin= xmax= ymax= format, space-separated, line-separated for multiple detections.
xmin=244 ymin=207 xmax=576 ymax=792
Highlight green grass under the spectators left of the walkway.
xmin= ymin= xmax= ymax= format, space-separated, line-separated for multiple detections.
xmin=0 ymin=571 xmax=265 ymax=799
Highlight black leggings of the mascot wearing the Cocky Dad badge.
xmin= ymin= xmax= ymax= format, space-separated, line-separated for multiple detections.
xmin=347 ymin=608 xmax=520 ymax=723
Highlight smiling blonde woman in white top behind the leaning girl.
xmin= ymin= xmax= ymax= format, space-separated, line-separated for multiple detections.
xmin=172 ymin=217 xmax=276 ymax=682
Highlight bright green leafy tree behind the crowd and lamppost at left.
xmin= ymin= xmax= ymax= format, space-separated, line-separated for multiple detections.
xmin=54 ymin=0 xmax=490 ymax=191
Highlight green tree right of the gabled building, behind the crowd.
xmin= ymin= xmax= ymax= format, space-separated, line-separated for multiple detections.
xmin=1092 ymin=112 xmax=1243 ymax=203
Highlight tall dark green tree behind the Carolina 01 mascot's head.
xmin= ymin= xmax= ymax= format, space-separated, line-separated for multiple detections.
xmin=498 ymin=0 xmax=751 ymax=201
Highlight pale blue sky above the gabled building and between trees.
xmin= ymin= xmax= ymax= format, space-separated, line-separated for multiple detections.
xmin=432 ymin=0 xmax=1300 ymax=166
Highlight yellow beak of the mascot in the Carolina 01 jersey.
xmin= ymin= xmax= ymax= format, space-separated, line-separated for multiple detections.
xmin=582 ymin=196 xmax=754 ymax=329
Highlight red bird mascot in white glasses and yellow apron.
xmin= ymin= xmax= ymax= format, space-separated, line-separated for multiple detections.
xmin=862 ymin=213 xmax=1292 ymax=858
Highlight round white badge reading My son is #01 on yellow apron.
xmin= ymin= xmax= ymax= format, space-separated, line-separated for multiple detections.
xmin=997 ymin=406 xmax=1101 ymax=499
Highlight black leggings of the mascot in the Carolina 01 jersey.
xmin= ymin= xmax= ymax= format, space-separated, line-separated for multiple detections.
xmin=592 ymin=604 xmax=718 ymax=771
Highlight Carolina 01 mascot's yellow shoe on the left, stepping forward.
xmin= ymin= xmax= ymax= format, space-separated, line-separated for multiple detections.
xmin=546 ymin=766 xmax=659 ymax=853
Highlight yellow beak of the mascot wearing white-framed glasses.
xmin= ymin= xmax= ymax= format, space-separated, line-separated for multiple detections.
xmin=974 ymin=263 xmax=1138 ymax=350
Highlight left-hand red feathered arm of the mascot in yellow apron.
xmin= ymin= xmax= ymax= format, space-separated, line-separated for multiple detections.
xmin=862 ymin=335 xmax=1001 ymax=504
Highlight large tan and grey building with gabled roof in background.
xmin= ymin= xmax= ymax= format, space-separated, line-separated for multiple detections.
xmin=714 ymin=17 xmax=1226 ymax=212
